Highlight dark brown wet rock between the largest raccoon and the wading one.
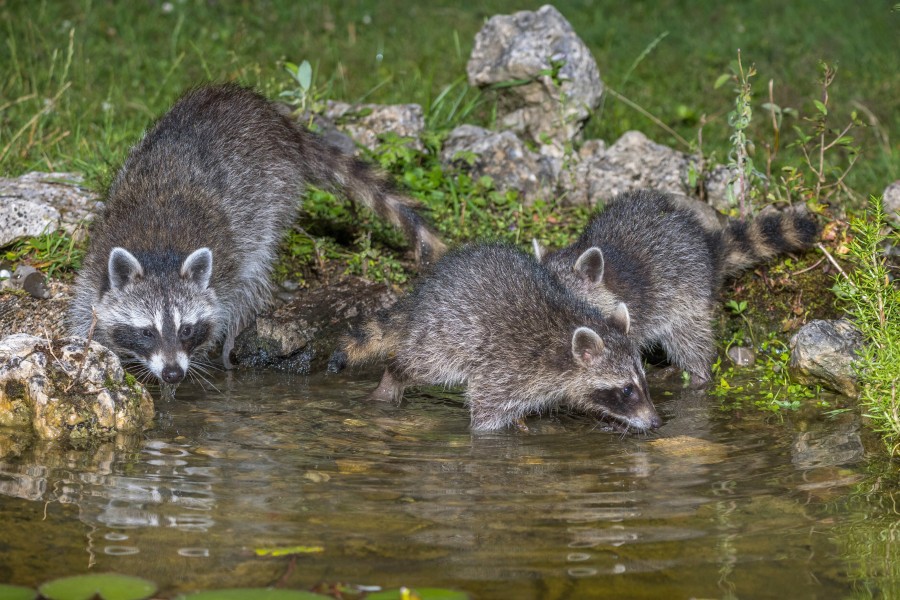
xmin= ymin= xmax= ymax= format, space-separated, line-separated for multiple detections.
xmin=234 ymin=277 xmax=397 ymax=375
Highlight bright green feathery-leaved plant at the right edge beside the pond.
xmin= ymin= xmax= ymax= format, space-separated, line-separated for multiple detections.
xmin=834 ymin=196 xmax=900 ymax=455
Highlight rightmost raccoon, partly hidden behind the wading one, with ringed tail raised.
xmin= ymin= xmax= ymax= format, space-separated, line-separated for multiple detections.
xmin=535 ymin=191 xmax=818 ymax=387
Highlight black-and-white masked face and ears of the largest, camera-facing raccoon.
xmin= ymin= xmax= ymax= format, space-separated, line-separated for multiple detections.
xmin=95 ymin=248 xmax=221 ymax=384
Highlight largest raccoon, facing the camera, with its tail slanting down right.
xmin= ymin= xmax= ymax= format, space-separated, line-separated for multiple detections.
xmin=68 ymin=84 xmax=444 ymax=384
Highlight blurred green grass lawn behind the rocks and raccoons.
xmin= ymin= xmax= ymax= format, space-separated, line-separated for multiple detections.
xmin=0 ymin=0 xmax=900 ymax=202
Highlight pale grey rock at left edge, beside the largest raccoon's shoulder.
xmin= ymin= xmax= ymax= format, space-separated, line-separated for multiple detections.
xmin=0 ymin=172 xmax=100 ymax=246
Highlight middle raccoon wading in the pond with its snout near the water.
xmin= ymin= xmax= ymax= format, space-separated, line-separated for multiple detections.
xmin=337 ymin=244 xmax=661 ymax=430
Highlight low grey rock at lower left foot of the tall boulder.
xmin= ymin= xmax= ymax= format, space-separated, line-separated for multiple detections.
xmin=441 ymin=125 xmax=560 ymax=203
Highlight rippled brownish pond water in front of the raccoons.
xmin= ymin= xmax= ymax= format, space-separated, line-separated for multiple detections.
xmin=0 ymin=372 xmax=900 ymax=599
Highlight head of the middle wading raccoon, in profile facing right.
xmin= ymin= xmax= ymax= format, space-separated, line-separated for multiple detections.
xmin=572 ymin=304 xmax=662 ymax=431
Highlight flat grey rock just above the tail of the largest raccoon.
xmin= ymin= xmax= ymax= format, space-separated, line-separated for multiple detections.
xmin=324 ymin=100 xmax=425 ymax=150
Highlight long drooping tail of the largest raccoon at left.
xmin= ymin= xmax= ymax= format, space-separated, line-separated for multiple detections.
xmin=304 ymin=134 xmax=447 ymax=267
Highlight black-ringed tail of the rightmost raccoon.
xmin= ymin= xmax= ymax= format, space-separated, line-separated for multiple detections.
xmin=722 ymin=209 xmax=819 ymax=276
